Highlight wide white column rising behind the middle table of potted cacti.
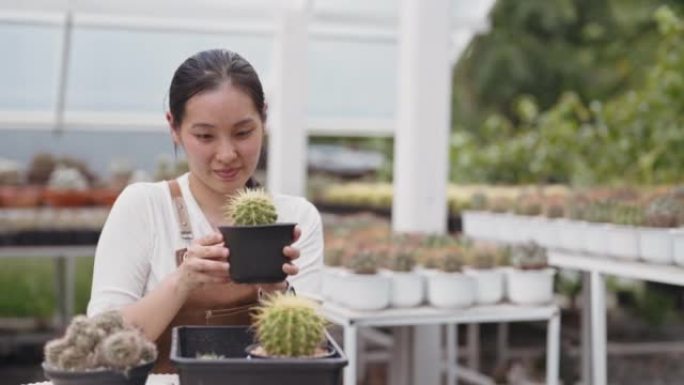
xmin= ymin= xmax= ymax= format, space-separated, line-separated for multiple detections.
xmin=392 ymin=0 xmax=451 ymax=233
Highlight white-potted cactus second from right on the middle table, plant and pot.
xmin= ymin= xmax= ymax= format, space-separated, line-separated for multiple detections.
xmin=463 ymin=244 xmax=504 ymax=304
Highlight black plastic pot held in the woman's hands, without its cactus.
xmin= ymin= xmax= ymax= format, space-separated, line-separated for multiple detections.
xmin=219 ymin=223 xmax=295 ymax=283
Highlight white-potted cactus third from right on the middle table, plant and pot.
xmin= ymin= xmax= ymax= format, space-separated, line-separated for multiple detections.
xmin=424 ymin=247 xmax=477 ymax=308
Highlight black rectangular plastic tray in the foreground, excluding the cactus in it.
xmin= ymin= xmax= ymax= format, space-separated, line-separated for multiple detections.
xmin=171 ymin=326 xmax=347 ymax=385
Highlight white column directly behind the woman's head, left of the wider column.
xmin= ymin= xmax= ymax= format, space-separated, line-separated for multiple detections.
xmin=267 ymin=0 xmax=311 ymax=196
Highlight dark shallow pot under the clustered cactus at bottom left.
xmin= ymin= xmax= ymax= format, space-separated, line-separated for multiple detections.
xmin=43 ymin=361 xmax=154 ymax=385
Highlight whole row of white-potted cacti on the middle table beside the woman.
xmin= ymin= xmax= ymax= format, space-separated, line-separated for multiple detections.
xmin=322 ymin=237 xmax=554 ymax=310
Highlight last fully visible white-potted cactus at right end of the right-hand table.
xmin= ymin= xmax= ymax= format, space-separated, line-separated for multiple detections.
xmin=639 ymin=194 xmax=684 ymax=264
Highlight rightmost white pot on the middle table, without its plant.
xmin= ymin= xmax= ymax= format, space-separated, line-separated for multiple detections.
xmin=506 ymin=268 xmax=556 ymax=305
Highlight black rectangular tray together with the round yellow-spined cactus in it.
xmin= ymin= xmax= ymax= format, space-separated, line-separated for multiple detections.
xmin=171 ymin=293 xmax=347 ymax=385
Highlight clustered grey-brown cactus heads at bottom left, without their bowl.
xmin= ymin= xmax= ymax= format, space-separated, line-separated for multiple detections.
xmin=45 ymin=311 xmax=157 ymax=372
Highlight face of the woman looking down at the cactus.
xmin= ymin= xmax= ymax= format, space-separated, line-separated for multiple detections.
xmin=167 ymin=82 xmax=264 ymax=194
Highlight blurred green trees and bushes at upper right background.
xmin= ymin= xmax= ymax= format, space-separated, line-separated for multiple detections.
xmin=451 ymin=0 xmax=684 ymax=185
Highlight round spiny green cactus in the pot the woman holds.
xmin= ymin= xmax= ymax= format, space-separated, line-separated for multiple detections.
xmin=223 ymin=189 xmax=278 ymax=226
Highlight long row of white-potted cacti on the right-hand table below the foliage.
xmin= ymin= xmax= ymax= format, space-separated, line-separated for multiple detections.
xmin=462 ymin=188 xmax=684 ymax=266
